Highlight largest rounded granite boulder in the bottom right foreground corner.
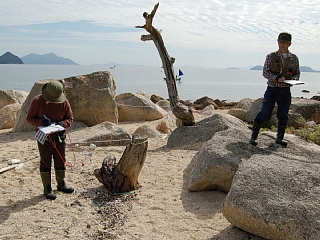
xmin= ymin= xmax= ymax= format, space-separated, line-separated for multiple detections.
xmin=222 ymin=136 xmax=320 ymax=240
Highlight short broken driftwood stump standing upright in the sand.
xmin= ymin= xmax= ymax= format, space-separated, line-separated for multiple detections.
xmin=94 ymin=136 xmax=148 ymax=193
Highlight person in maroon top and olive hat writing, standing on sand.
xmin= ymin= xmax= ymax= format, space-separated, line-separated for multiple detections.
xmin=26 ymin=81 xmax=74 ymax=200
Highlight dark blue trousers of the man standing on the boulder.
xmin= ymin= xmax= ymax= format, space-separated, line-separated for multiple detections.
xmin=254 ymin=86 xmax=291 ymax=126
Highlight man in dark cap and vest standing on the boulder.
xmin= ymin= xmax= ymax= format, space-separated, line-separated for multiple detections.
xmin=250 ymin=32 xmax=300 ymax=147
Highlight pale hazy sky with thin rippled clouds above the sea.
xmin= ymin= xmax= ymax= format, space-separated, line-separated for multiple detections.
xmin=0 ymin=0 xmax=320 ymax=70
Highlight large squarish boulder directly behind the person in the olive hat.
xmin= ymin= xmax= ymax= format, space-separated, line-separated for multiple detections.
xmin=12 ymin=71 xmax=118 ymax=132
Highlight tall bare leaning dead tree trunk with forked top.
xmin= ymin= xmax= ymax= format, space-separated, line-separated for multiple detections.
xmin=136 ymin=3 xmax=195 ymax=126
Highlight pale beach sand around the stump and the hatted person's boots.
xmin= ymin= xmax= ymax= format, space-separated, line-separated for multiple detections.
xmin=0 ymin=114 xmax=260 ymax=240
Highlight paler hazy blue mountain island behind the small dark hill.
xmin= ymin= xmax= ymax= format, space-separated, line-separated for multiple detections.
xmin=21 ymin=53 xmax=79 ymax=65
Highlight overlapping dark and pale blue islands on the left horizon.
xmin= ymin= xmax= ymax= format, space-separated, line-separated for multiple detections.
xmin=0 ymin=52 xmax=79 ymax=65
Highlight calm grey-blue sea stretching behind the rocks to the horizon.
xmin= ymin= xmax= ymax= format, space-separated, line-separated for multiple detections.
xmin=0 ymin=64 xmax=320 ymax=102
